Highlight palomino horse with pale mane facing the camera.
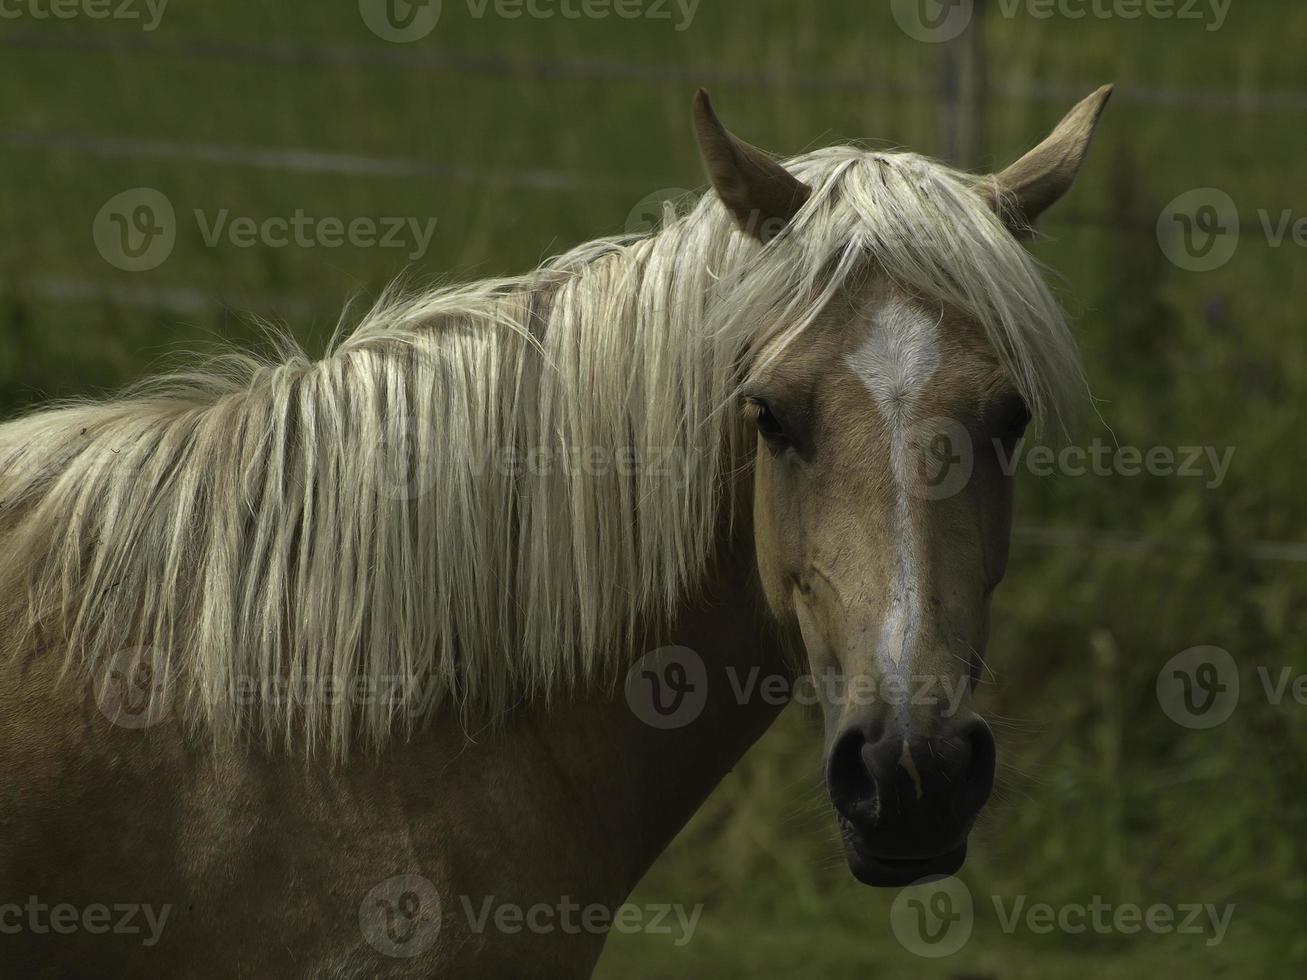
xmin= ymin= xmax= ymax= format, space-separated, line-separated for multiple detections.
xmin=0 ymin=88 xmax=1110 ymax=980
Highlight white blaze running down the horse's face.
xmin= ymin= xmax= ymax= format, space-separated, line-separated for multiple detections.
xmin=846 ymin=301 xmax=940 ymax=681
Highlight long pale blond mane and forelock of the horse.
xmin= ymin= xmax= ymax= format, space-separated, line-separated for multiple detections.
xmin=0 ymin=148 xmax=1084 ymax=753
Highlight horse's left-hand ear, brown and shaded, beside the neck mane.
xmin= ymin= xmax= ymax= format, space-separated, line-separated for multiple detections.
xmin=694 ymin=89 xmax=812 ymax=243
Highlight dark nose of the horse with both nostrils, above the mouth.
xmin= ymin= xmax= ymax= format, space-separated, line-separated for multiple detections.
xmin=826 ymin=716 xmax=996 ymax=851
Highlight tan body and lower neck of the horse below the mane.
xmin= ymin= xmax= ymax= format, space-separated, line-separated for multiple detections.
xmin=0 ymin=517 xmax=788 ymax=980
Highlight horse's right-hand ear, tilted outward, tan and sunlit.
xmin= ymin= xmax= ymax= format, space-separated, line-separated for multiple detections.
xmin=976 ymin=85 xmax=1112 ymax=239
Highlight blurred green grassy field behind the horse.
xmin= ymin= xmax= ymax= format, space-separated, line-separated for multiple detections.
xmin=0 ymin=0 xmax=1307 ymax=980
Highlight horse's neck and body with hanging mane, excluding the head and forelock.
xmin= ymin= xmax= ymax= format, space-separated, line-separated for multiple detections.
xmin=0 ymin=168 xmax=789 ymax=977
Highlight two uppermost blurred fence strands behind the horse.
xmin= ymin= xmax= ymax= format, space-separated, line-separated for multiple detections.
xmin=0 ymin=31 xmax=1291 ymax=237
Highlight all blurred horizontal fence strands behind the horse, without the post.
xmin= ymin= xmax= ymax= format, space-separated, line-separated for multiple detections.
xmin=0 ymin=31 xmax=1307 ymax=563
